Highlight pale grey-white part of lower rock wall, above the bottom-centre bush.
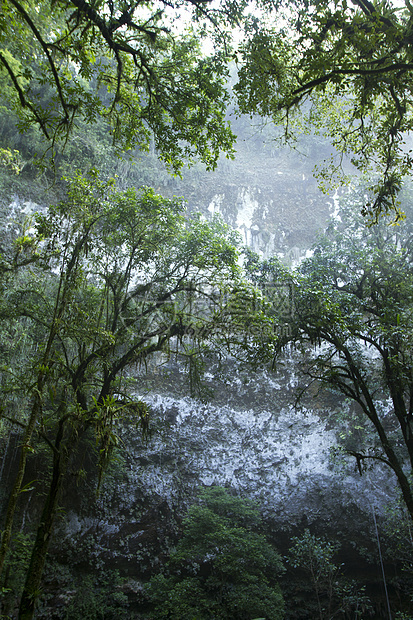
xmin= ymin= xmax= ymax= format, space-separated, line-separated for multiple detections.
xmin=67 ymin=358 xmax=395 ymax=530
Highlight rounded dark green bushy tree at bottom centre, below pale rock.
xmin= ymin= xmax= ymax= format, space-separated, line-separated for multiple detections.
xmin=148 ymin=487 xmax=284 ymax=620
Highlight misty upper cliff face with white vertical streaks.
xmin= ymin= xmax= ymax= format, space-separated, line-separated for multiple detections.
xmin=160 ymin=141 xmax=334 ymax=261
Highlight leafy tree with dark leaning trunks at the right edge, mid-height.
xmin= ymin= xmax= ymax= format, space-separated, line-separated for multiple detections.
xmin=247 ymin=190 xmax=413 ymax=518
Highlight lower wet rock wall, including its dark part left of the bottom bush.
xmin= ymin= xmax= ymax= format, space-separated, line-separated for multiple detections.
xmin=52 ymin=354 xmax=396 ymax=576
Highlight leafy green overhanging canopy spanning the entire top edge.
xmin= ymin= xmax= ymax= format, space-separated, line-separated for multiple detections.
xmin=0 ymin=0 xmax=413 ymax=221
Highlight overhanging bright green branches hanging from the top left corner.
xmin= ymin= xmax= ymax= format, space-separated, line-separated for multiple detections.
xmin=0 ymin=0 xmax=242 ymax=170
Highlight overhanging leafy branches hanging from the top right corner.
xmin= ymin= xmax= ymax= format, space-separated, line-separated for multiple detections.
xmin=236 ymin=0 xmax=413 ymax=221
